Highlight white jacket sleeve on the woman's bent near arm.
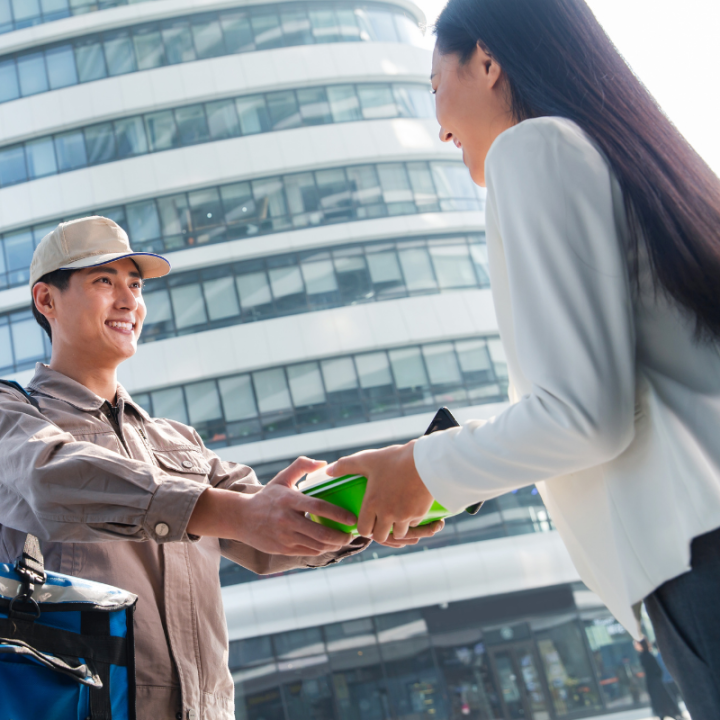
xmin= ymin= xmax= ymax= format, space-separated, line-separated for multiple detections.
xmin=414 ymin=118 xmax=635 ymax=510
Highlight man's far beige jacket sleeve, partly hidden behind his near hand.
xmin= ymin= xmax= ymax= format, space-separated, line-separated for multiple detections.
xmin=195 ymin=436 xmax=371 ymax=575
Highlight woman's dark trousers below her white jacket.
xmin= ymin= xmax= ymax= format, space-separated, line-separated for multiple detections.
xmin=645 ymin=529 xmax=720 ymax=720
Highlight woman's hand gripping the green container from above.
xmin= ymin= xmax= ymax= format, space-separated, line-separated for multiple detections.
xmin=327 ymin=440 xmax=437 ymax=547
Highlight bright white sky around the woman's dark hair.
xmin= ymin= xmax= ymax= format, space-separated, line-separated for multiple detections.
xmin=414 ymin=0 xmax=720 ymax=175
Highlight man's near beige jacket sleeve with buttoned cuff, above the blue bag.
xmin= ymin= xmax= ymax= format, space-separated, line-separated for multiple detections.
xmin=0 ymin=386 xmax=207 ymax=542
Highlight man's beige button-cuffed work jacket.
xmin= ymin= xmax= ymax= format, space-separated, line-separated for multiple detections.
xmin=0 ymin=363 xmax=367 ymax=720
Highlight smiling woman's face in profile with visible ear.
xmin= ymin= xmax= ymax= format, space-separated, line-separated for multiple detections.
xmin=430 ymin=45 xmax=515 ymax=187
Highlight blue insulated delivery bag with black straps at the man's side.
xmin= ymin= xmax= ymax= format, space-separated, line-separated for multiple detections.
xmin=0 ymin=535 xmax=137 ymax=720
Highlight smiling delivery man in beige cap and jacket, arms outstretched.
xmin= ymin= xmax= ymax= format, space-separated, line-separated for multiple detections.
xmin=0 ymin=217 xmax=440 ymax=720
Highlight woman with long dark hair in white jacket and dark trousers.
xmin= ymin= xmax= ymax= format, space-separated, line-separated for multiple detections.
xmin=330 ymin=0 xmax=720 ymax=720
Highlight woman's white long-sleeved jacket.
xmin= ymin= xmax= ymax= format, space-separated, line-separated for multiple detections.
xmin=414 ymin=118 xmax=720 ymax=637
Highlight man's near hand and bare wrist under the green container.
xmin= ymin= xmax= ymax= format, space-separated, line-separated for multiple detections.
xmin=187 ymin=457 xmax=356 ymax=556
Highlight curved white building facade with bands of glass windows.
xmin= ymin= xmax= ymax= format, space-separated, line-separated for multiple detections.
xmin=0 ymin=0 xmax=647 ymax=720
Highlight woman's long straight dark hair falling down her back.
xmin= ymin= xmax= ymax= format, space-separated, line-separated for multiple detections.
xmin=435 ymin=0 xmax=720 ymax=340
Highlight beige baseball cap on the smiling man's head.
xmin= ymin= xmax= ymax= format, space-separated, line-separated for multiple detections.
xmin=30 ymin=215 xmax=170 ymax=288
